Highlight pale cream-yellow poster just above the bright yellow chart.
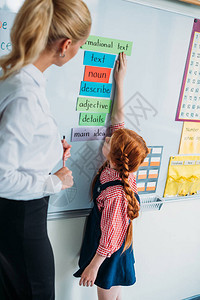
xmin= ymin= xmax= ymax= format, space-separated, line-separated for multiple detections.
xmin=178 ymin=122 xmax=200 ymax=154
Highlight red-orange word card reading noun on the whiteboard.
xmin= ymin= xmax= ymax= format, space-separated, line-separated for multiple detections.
xmin=83 ymin=66 xmax=111 ymax=83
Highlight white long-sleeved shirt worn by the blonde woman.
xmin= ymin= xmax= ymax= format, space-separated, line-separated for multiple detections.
xmin=0 ymin=64 xmax=63 ymax=200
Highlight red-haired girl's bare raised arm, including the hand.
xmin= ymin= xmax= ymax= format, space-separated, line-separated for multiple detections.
xmin=111 ymin=52 xmax=127 ymax=125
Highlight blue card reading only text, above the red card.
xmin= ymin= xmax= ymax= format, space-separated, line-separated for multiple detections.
xmin=83 ymin=51 xmax=116 ymax=69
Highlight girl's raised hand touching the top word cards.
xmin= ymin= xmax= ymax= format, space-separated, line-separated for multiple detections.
xmin=114 ymin=52 xmax=127 ymax=84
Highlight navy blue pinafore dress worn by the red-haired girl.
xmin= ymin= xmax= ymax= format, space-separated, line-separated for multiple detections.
xmin=74 ymin=180 xmax=138 ymax=289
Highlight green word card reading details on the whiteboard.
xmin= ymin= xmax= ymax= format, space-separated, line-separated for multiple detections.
xmin=79 ymin=113 xmax=107 ymax=126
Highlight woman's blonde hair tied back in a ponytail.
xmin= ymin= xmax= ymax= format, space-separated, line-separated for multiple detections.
xmin=0 ymin=0 xmax=91 ymax=80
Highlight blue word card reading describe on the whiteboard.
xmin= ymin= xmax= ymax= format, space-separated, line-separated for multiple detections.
xmin=80 ymin=81 xmax=112 ymax=98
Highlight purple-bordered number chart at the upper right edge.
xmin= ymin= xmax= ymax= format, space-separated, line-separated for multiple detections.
xmin=176 ymin=19 xmax=200 ymax=122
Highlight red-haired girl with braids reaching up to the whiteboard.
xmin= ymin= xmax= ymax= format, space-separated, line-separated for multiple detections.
xmin=74 ymin=53 xmax=148 ymax=300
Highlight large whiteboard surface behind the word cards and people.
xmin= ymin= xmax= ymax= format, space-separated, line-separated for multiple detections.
xmin=0 ymin=0 xmax=194 ymax=217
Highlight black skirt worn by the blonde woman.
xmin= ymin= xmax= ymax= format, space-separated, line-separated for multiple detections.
xmin=0 ymin=197 xmax=55 ymax=300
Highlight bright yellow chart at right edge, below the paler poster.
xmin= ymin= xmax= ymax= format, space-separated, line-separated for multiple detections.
xmin=164 ymin=155 xmax=200 ymax=197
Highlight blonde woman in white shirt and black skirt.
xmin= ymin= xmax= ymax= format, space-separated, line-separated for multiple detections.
xmin=0 ymin=0 xmax=91 ymax=300
